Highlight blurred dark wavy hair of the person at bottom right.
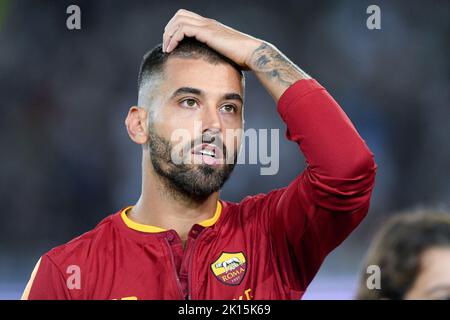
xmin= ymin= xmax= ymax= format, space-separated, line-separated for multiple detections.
xmin=356 ymin=210 xmax=450 ymax=300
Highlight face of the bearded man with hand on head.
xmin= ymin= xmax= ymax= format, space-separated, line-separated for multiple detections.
xmin=145 ymin=57 xmax=243 ymax=198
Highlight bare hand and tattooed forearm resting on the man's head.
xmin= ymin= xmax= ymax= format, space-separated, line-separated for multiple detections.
xmin=163 ymin=9 xmax=310 ymax=102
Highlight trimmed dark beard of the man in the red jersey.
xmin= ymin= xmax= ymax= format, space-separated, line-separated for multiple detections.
xmin=148 ymin=128 xmax=237 ymax=201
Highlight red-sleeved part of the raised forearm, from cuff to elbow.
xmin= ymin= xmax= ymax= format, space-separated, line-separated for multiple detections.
xmin=278 ymin=79 xmax=374 ymax=179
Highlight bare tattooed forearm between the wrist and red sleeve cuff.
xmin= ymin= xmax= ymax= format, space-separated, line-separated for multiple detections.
xmin=247 ymin=41 xmax=311 ymax=102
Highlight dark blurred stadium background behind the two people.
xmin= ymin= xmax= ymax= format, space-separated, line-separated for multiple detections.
xmin=0 ymin=0 xmax=450 ymax=299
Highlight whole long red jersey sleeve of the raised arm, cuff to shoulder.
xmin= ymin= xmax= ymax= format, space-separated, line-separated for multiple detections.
xmin=261 ymin=79 xmax=376 ymax=291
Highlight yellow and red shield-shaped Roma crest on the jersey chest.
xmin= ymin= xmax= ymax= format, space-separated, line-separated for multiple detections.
xmin=211 ymin=252 xmax=247 ymax=286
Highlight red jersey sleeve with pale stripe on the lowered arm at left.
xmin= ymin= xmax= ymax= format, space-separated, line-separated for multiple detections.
xmin=22 ymin=255 xmax=70 ymax=300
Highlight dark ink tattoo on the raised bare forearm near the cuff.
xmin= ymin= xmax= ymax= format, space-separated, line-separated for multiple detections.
xmin=250 ymin=43 xmax=311 ymax=87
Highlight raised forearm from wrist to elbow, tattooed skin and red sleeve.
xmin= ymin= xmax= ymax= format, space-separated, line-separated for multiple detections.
xmin=247 ymin=40 xmax=373 ymax=178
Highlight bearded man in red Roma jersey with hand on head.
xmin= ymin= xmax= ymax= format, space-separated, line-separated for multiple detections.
xmin=23 ymin=10 xmax=376 ymax=300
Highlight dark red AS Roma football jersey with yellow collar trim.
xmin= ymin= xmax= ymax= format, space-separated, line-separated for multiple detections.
xmin=23 ymin=80 xmax=376 ymax=300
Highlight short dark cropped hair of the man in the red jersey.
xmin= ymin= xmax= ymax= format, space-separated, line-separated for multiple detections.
xmin=138 ymin=37 xmax=244 ymax=100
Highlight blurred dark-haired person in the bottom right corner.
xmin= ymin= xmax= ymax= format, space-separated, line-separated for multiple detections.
xmin=356 ymin=210 xmax=450 ymax=300
